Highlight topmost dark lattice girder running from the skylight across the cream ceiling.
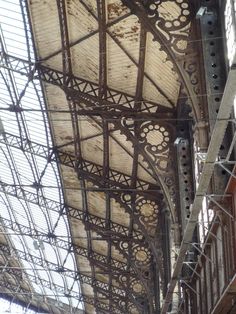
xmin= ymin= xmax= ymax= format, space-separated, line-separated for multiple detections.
xmin=0 ymin=51 xmax=173 ymax=114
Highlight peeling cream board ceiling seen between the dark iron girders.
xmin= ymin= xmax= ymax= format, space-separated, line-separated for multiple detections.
xmin=26 ymin=0 xmax=195 ymax=314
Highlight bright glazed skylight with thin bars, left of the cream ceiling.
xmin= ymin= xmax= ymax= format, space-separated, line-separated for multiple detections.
xmin=0 ymin=0 xmax=83 ymax=313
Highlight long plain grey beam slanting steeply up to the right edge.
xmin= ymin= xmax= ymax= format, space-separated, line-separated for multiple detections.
xmin=161 ymin=65 xmax=236 ymax=314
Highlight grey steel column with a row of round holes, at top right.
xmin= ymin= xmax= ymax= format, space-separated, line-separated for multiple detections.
xmin=199 ymin=0 xmax=229 ymax=194
